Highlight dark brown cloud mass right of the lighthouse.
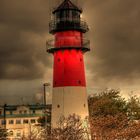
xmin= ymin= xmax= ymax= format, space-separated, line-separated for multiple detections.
xmin=85 ymin=0 xmax=140 ymax=85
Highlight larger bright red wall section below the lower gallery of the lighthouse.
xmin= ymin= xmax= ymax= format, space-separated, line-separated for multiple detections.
xmin=53 ymin=50 xmax=86 ymax=87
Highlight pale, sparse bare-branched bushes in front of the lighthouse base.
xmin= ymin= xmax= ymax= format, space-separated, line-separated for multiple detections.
xmin=22 ymin=114 xmax=90 ymax=140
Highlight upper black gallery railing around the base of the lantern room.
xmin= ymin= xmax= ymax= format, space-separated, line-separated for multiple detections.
xmin=49 ymin=19 xmax=89 ymax=34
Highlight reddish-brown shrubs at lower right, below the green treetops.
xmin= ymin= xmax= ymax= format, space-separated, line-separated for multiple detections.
xmin=90 ymin=114 xmax=140 ymax=140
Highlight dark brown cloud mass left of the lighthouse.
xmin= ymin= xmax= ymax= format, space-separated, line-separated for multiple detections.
xmin=0 ymin=0 xmax=52 ymax=79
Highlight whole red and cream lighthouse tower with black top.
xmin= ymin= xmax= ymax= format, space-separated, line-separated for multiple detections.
xmin=47 ymin=0 xmax=90 ymax=127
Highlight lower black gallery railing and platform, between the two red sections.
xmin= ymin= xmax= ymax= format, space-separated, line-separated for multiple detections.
xmin=46 ymin=39 xmax=90 ymax=53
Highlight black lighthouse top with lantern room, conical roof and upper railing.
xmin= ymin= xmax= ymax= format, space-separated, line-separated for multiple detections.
xmin=49 ymin=0 xmax=89 ymax=34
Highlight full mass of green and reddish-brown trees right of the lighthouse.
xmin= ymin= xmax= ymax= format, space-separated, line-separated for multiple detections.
xmin=89 ymin=90 xmax=140 ymax=140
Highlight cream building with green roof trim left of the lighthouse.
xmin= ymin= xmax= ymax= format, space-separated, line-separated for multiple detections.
xmin=0 ymin=104 xmax=51 ymax=140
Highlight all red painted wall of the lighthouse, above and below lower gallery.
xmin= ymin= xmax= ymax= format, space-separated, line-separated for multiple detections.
xmin=53 ymin=31 xmax=86 ymax=87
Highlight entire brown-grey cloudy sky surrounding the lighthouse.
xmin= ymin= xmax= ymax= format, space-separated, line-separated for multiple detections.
xmin=0 ymin=0 xmax=140 ymax=104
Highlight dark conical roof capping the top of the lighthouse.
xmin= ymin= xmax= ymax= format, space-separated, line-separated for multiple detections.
xmin=53 ymin=0 xmax=82 ymax=13
